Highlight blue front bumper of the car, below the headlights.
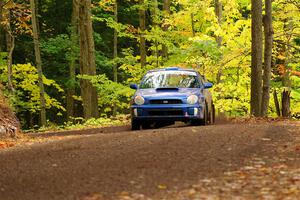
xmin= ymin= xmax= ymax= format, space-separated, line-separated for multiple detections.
xmin=131 ymin=104 xmax=204 ymax=121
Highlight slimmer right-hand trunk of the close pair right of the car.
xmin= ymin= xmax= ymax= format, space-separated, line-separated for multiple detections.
xmin=261 ymin=0 xmax=273 ymax=117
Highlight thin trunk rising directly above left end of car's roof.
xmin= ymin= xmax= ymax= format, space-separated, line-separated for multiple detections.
xmin=139 ymin=0 xmax=147 ymax=67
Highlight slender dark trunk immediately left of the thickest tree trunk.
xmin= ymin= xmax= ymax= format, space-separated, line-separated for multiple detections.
xmin=66 ymin=0 xmax=79 ymax=120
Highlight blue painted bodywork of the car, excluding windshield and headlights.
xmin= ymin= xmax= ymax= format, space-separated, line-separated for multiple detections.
xmin=131 ymin=67 xmax=211 ymax=121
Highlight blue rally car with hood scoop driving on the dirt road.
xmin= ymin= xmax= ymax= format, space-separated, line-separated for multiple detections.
xmin=130 ymin=67 xmax=215 ymax=130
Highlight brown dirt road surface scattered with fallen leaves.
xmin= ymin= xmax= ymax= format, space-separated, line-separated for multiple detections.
xmin=0 ymin=122 xmax=300 ymax=200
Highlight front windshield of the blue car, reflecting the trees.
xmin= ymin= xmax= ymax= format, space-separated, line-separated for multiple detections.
xmin=140 ymin=71 xmax=200 ymax=89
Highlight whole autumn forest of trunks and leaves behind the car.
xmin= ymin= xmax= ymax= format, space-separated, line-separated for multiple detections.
xmin=0 ymin=0 xmax=300 ymax=129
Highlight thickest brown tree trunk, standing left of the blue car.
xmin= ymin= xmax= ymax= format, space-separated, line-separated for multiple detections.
xmin=79 ymin=0 xmax=99 ymax=119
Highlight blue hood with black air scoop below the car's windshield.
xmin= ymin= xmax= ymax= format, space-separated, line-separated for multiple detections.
xmin=136 ymin=88 xmax=200 ymax=98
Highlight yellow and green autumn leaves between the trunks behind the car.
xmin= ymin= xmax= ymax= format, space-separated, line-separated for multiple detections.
xmin=0 ymin=0 xmax=300 ymax=130
